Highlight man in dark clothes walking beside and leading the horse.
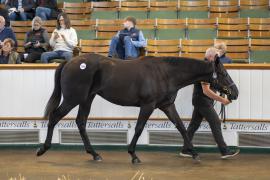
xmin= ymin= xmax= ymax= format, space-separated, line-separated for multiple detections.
xmin=180 ymin=47 xmax=239 ymax=159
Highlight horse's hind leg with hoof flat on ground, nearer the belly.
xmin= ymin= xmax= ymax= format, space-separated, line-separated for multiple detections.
xmin=76 ymin=95 xmax=102 ymax=161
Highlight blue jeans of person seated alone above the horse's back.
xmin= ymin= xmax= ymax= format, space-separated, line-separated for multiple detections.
xmin=108 ymin=36 xmax=139 ymax=59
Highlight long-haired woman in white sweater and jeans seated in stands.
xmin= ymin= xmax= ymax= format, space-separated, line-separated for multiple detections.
xmin=41 ymin=13 xmax=78 ymax=63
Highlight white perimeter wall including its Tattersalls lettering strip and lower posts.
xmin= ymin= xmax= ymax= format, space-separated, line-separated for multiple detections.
xmin=0 ymin=69 xmax=270 ymax=146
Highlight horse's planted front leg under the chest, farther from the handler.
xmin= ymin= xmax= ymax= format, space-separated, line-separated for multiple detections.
xmin=128 ymin=105 xmax=154 ymax=164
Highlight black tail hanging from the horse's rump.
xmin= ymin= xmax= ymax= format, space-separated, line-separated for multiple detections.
xmin=44 ymin=61 xmax=67 ymax=118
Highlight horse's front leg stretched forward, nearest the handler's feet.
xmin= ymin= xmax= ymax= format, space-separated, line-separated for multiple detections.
xmin=160 ymin=103 xmax=200 ymax=161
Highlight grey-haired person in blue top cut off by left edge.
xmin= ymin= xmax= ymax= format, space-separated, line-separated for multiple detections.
xmin=0 ymin=16 xmax=17 ymax=47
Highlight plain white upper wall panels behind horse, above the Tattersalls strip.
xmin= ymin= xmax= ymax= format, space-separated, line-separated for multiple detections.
xmin=0 ymin=69 xmax=270 ymax=120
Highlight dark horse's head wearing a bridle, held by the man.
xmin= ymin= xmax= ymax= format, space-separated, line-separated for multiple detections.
xmin=212 ymin=58 xmax=238 ymax=101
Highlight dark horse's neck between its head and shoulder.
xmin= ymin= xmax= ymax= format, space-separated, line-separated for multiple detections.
xmin=171 ymin=61 xmax=213 ymax=89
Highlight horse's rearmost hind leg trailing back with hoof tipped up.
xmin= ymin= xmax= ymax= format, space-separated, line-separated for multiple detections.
xmin=37 ymin=101 xmax=75 ymax=156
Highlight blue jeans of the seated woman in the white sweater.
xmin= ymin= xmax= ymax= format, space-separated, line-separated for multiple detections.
xmin=40 ymin=51 xmax=73 ymax=63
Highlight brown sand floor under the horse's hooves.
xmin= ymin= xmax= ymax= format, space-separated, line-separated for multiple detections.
xmin=0 ymin=149 xmax=270 ymax=180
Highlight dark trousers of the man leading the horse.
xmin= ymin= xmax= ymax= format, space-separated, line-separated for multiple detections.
xmin=183 ymin=106 xmax=228 ymax=154
